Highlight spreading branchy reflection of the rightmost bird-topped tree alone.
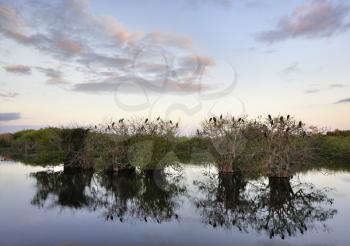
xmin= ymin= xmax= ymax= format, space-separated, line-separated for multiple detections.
xmin=254 ymin=178 xmax=337 ymax=239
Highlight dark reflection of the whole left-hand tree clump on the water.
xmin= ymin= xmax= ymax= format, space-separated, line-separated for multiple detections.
xmin=31 ymin=171 xmax=186 ymax=223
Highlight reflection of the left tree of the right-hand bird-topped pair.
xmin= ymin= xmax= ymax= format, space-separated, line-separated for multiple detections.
xmin=194 ymin=173 xmax=254 ymax=231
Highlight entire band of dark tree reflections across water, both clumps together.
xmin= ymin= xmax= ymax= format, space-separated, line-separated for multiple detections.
xmin=31 ymin=170 xmax=337 ymax=239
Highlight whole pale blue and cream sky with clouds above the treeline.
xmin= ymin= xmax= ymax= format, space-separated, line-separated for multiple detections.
xmin=0 ymin=0 xmax=350 ymax=132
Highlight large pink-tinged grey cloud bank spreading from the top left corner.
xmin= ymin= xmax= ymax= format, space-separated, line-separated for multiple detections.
xmin=0 ymin=0 xmax=215 ymax=93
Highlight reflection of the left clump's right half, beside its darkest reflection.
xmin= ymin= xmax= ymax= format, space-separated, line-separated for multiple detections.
xmin=97 ymin=171 xmax=186 ymax=223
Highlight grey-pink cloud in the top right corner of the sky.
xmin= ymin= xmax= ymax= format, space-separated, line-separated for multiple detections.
xmin=256 ymin=0 xmax=350 ymax=44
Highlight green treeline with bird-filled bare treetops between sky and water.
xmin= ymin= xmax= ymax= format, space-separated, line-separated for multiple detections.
xmin=0 ymin=115 xmax=350 ymax=177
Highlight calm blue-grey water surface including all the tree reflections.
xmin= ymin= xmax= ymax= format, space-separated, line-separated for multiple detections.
xmin=0 ymin=161 xmax=350 ymax=245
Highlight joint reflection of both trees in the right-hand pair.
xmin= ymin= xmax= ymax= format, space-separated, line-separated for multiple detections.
xmin=194 ymin=173 xmax=337 ymax=239
